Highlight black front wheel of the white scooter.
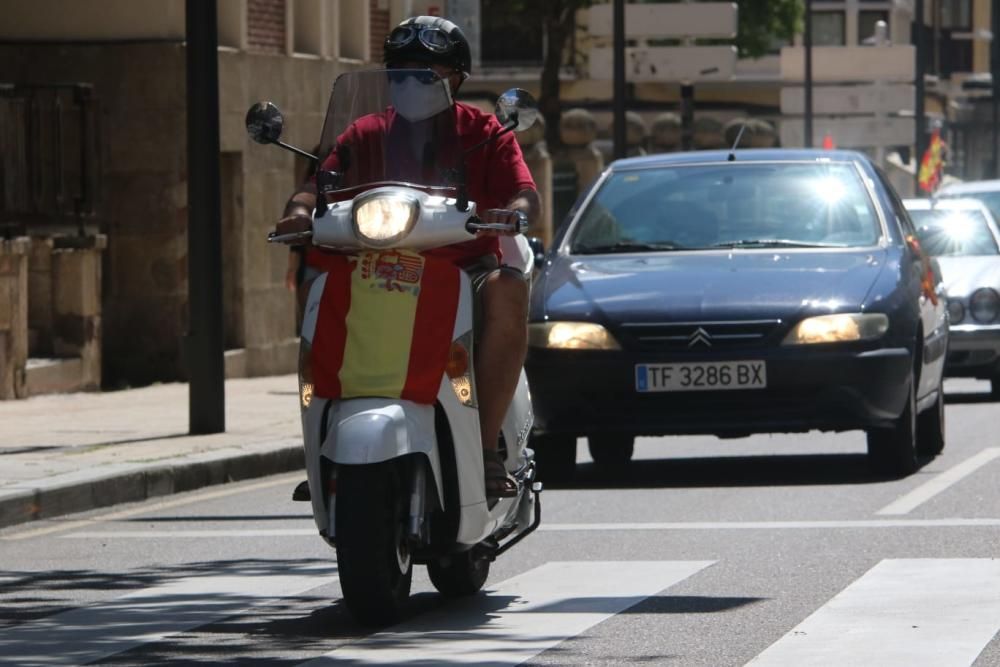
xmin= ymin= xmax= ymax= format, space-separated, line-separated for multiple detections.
xmin=336 ymin=461 xmax=413 ymax=626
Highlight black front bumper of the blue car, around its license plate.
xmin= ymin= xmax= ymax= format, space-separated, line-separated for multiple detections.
xmin=527 ymin=348 xmax=912 ymax=436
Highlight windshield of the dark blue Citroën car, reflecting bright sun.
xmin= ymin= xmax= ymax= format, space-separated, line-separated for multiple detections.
xmin=571 ymin=162 xmax=881 ymax=254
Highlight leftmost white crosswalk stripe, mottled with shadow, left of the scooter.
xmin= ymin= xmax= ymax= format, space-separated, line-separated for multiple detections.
xmin=0 ymin=564 xmax=337 ymax=665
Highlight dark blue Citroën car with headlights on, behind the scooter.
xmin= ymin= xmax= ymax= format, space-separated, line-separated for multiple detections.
xmin=527 ymin=149 xmax=948 ymax=481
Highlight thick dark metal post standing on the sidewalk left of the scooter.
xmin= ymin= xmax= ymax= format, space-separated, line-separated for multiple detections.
xmin=185 ymin=0 xmax=226 ymax=434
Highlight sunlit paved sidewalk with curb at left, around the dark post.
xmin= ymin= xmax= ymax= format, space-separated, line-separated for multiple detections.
xmin=0 ymin=375 xmax=305 ymax=528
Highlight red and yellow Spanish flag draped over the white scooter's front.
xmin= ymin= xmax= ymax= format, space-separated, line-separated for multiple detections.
xmin=312 ymin=250 xmax=460 ymax=404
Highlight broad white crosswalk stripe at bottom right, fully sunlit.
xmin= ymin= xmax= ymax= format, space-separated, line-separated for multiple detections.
xmin=748 ymin=558 xmax=1000 ymax=667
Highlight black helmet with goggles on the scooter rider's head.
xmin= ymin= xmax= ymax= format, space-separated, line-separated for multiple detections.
xmin=382 ymin=16 xmax=472 ymax=76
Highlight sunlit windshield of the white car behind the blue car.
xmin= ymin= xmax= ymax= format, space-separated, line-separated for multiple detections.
xmin=910 ymin=209 xmax=1000 ymax=256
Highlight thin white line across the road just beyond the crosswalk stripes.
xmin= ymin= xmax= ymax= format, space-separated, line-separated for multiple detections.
xmin=60 ymin=519 xmax=1000 ymax=540
